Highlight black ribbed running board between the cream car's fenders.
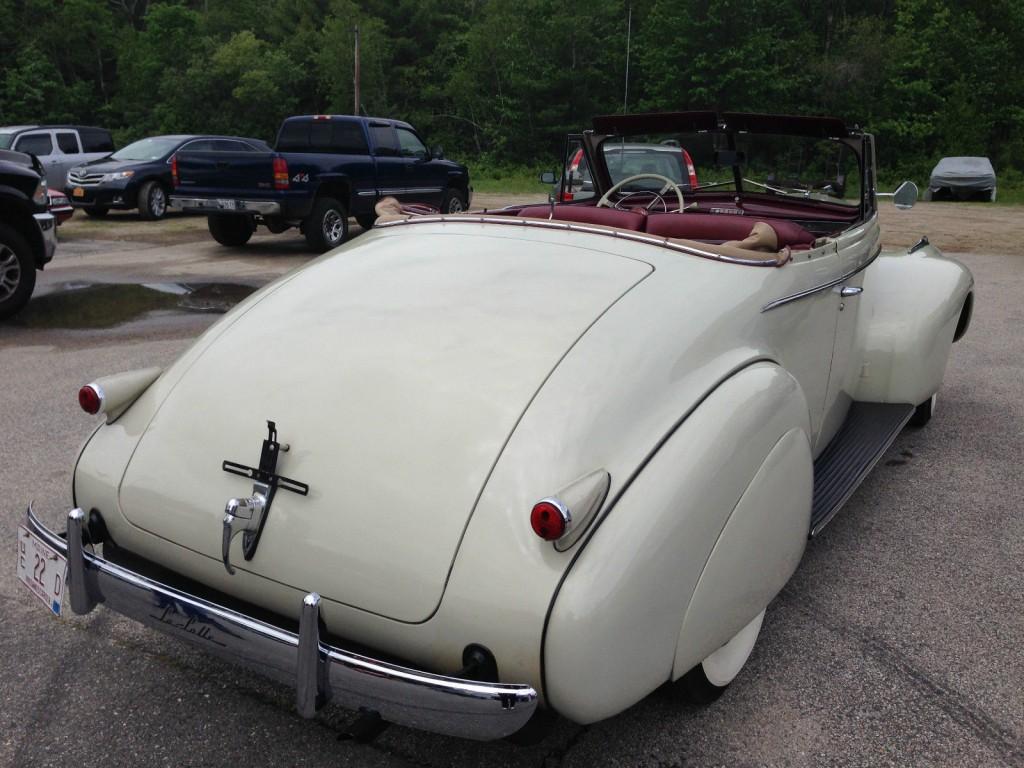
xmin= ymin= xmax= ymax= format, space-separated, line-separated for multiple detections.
xmin=808 ymin=402 xmax=913 ymax=538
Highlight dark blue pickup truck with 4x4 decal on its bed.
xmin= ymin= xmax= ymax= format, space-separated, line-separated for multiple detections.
xmin=171 ymin=115 xmax=472 ymax=252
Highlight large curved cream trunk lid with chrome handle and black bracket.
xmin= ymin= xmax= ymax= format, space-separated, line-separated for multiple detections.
xmin=120 ymin=227 xmax=651 ymax=622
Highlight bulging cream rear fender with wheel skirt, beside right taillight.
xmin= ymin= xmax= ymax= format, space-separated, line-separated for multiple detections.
xmin=543 ymin=362 xmax=811 ymax=723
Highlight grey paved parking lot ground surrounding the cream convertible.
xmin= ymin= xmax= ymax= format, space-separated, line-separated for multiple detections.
xmin=0 ymin=197 xmax=1024 ymax=768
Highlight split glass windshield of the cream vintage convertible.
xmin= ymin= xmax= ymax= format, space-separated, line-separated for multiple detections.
xmin=601 ymin=132 xmax=861 ymax=206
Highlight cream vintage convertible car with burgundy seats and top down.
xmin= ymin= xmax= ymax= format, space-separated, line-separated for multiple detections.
xmin=19 ymin=112 xmax=973 ymax=739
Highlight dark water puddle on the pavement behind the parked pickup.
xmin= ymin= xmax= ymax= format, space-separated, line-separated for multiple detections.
xmin=9 ymin=283 xmax=258 ymax=329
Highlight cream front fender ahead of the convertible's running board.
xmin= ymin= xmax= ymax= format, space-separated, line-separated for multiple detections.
xmin=848 ymin=245 xmax=974 ymax=406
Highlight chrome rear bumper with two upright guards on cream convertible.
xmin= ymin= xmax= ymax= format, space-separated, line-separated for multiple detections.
xmin=26 ymin=506 xmax=537 ymax=740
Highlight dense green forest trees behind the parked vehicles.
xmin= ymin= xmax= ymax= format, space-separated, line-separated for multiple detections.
xmin=0 ymin=0 xmax=1024 ymax=196
